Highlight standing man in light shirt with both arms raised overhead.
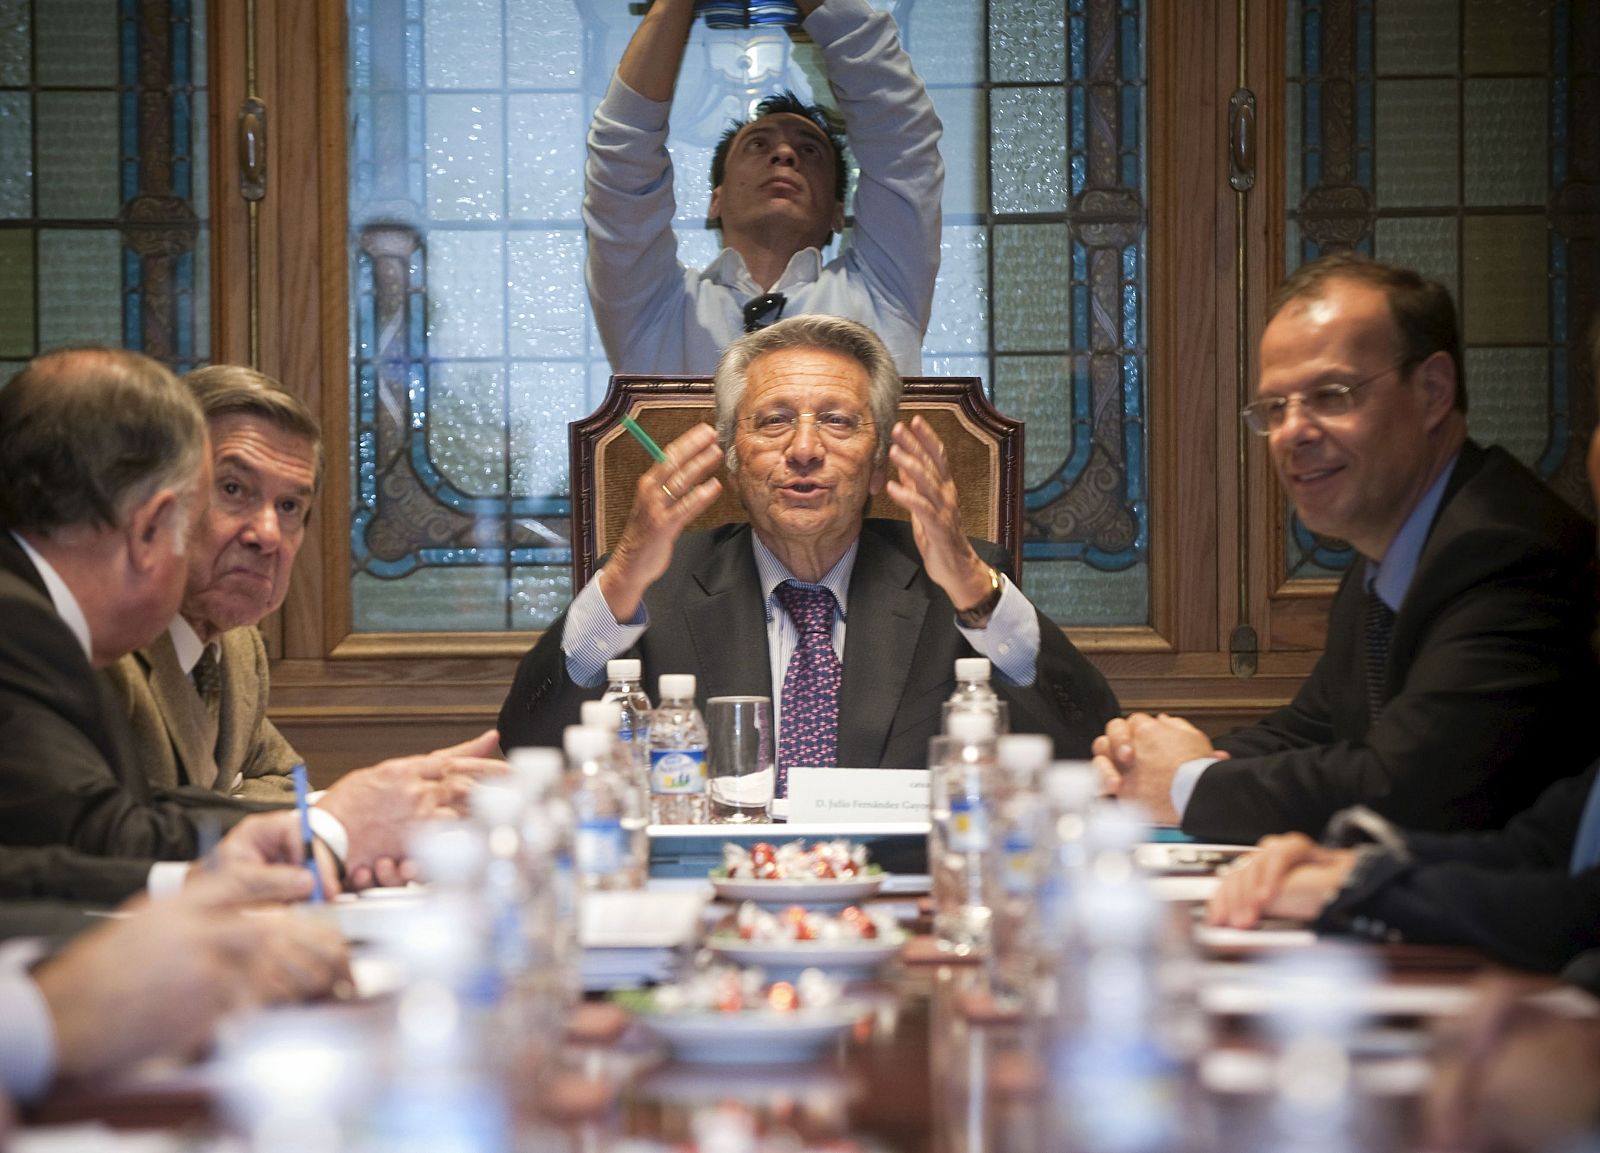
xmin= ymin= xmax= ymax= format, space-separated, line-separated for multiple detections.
xmin=584 ymin=0 xmax=944 ymax=376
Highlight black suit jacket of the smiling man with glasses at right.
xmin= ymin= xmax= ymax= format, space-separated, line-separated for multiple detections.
xmin=1184 ymin=441 xmax=1600 ymax=841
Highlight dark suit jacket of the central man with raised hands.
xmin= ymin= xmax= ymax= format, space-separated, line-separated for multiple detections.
xmin=499 ymin=520 xmax=1117 ymax=769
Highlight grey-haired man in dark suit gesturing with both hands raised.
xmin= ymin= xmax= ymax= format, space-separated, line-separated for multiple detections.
xmin=499 ymin=317 xmax=1117 ymax=768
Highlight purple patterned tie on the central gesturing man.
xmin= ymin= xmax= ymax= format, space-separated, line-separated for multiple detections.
xmin=773 ymin=580 xmax=845 ymax=796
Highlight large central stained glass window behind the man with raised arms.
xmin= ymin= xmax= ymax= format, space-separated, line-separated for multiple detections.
xmin=349 ymin=0 xmax=1149 ymax=630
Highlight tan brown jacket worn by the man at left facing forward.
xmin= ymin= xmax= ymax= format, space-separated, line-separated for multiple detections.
xmin=106 ymin=627 xmax=299 ymax=801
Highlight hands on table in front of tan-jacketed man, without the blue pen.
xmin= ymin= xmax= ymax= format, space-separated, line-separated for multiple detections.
xmin=317 ymin=729 xmax=506 ymax=889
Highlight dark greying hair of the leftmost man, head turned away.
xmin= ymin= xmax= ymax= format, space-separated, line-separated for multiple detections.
xmin=0 ymin=349 xmax=206 ymax=534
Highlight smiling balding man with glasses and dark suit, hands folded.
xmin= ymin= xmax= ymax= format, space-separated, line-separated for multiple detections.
xmin=1094 ymin=253 xmax=1600 ymax=843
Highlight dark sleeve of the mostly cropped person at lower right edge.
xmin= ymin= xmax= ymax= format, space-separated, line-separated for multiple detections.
xmin=1318 ymin=761 xmax=1600 ymax=972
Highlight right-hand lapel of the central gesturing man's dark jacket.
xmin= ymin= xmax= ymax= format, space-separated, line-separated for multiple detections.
xmin=838 ymin=531 xmax=928 ymax=768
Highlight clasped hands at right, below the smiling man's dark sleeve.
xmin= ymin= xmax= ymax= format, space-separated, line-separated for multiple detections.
xmin=1206 ymin=833 xmax=1355 ymax=929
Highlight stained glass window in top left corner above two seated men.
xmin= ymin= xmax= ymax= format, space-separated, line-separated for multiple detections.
xmin=0 ymin=0 xmax=211 ymax=379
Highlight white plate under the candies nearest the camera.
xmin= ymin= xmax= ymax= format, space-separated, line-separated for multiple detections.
xmin=640 ymin=1001 xmax=866 ymax=1065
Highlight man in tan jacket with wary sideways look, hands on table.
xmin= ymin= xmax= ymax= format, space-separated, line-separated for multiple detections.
xmin=101 ymin=365 xmax=501 ymax=888
